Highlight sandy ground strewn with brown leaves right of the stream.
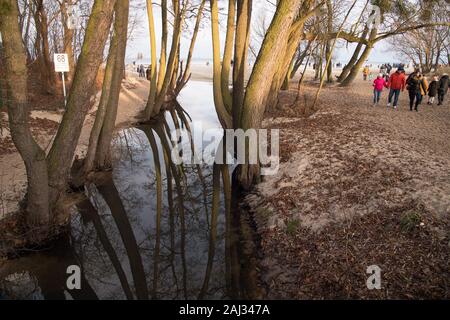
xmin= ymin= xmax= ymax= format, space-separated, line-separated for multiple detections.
xmin=247 ymin=81 xmax=450 ymax=299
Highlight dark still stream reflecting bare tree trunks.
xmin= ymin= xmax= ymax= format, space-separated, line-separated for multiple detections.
xmin=0 ymin=82 xmax=246 ymax=299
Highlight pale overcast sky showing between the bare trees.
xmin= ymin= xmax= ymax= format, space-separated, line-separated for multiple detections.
xmin=127 ymin=0 xmax=400 ymax=63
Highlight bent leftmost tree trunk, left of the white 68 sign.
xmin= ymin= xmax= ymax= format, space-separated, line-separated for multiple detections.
xmin=0 ymin=0 xmax=50 ymax=230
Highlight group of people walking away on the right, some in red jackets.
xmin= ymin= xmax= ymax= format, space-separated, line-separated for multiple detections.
xmin=373 ymin=66 xmax=450 ymax=112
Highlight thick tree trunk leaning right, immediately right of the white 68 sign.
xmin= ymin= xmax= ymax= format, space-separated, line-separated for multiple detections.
xmin=47 ymin=0 xmax=116 ymax=205
